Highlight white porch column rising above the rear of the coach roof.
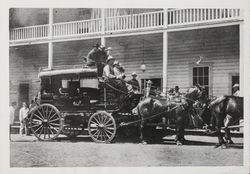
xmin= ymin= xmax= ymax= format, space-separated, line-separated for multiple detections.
xmin=48 ymin=8 xmax=53 ymax=69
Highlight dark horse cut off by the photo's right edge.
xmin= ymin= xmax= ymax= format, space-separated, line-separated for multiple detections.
xmin=198 ymin=95 xmax=243 ymax=148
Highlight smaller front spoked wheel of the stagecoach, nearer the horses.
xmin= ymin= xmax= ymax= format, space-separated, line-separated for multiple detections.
xmin=88 ymin=111 xmax=116 ymax=143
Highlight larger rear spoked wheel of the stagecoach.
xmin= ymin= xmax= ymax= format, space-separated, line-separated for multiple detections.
xmin=30 ymin=104 xmax=62 ymax=141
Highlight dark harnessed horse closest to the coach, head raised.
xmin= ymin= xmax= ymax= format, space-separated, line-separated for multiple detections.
xmin=136 ymin=84 xmax=206 ymax=145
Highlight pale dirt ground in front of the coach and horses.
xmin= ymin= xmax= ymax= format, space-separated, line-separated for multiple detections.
xmin=10 ymin=135 xmax=243 ymax=167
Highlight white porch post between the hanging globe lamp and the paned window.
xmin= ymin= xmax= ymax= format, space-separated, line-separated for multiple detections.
xmin=162 ymin=9 xmax=168 ymax=93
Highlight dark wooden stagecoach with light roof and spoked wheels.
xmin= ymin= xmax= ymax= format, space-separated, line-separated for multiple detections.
xmin=29 ymin=66 xmax=141 ymax=142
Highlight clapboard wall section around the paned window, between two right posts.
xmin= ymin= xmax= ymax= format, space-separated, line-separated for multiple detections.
xmin=167 ymin=26 xmax=239 ymax=96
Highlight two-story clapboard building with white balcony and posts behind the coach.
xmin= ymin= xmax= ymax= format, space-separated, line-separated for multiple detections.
xmin=9 ymin=8 xmax=244 ymax=107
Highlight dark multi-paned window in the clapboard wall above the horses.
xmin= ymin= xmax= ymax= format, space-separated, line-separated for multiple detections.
xmin=193 ymin=66 xmax=209 ymax=94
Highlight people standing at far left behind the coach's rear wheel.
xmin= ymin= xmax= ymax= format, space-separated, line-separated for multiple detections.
xmin=9 ymin=100 xmax=36 ymax=138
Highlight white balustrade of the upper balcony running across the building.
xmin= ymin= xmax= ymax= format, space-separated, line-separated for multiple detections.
xmin=9 ymin=8 xmax=243 ymax=44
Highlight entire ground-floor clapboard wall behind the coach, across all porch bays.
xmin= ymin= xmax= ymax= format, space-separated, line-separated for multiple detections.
xmin=10 ymin=26 xmax=239 ymax=104
